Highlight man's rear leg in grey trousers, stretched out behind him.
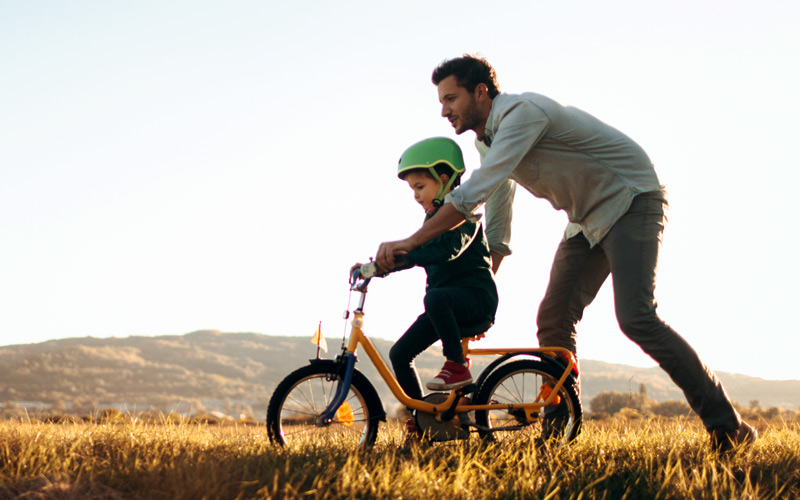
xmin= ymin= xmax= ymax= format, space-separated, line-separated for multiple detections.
xmin=600 ymin=189 xmax=741 ymax=431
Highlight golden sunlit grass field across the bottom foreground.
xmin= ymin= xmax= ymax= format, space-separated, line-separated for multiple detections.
xmin=0 ymin=419 xmax=800 ymax=500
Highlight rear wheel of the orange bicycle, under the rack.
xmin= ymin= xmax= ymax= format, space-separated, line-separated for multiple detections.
xmin=475 ymin=359 xmax=583 ymax=445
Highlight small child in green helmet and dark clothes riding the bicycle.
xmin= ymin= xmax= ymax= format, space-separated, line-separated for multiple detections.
xmin=354 ymin=137 xmax=497 ymax=399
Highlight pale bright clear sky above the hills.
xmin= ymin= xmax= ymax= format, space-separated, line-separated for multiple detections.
xmin=0 ymin=0 xmax=800 ymax=379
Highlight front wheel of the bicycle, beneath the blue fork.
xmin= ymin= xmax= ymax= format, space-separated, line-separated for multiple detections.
xmin=267 ymin=363 xmax=383 ymax=447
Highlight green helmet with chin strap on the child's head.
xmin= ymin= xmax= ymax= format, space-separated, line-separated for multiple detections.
xmin=397 ymin=137 xmax=466 ymax=206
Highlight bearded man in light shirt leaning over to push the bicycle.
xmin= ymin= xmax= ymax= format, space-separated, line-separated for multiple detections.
xmin=376 ymin=55 xmax=757 ymax=450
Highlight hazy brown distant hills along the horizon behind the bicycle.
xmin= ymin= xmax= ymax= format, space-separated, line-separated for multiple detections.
xmin=0 ymin=331 xmax=800 ymax=417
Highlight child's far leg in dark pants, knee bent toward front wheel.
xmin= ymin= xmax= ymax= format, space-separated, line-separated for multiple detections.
xmin=389 ymin=313 xmax=439 ymax=399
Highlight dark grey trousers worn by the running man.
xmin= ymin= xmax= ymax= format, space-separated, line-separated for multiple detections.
xmin=537 ymin=192 xmax=741 ymax=430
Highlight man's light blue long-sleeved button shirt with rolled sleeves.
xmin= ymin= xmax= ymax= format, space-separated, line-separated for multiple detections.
xmin=445 ymin=93 xmax=662 ymax=250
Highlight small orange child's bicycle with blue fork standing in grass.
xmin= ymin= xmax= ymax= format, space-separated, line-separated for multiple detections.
xmin=267 ymin=265 xmax=583 ymax=448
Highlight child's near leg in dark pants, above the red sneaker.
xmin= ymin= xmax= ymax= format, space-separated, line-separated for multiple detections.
xmin=425 ymin=287 xmax=497 ymax=363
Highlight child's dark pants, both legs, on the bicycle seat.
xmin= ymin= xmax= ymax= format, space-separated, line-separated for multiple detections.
xmin=389 ymin=287 xmax=497 ymax=399
